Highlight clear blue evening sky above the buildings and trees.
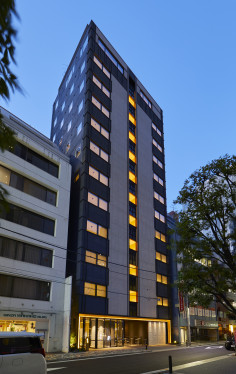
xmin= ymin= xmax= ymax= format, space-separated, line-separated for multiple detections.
xmin=0 ymin=0 xmax=236 ymax=211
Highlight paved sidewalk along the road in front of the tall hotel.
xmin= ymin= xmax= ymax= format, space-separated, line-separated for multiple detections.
xmin=46 ymin=341 xmax=225 ymax=362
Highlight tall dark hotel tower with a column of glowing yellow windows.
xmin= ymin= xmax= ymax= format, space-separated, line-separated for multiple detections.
xmin=51 ymin=21 xmax=171 ymax=348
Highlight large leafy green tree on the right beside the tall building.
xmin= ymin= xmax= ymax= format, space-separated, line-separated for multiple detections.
xmin=175 ymin=155 xmax=236 ymax=316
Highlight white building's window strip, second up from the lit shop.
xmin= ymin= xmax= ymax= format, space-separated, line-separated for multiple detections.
xmin=0 ymin=236 xmax=53 ymax=267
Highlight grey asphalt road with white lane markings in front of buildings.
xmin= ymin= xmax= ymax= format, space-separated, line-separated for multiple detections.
xmin=47 ymin=345 xmax=236 ymax=374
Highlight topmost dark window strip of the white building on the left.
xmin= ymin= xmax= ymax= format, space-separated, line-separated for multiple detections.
xmin=9 ymin=142 xmax=59 ymax=178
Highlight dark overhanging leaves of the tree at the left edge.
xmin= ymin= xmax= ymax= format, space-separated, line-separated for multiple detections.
xmin=0 ymin=0 xmax=21 ymax=210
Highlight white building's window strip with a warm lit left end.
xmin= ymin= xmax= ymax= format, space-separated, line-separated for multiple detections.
xmin=0 ymin=166 xmax=57 ymax=206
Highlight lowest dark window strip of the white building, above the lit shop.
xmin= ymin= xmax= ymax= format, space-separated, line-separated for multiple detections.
xmin=0 ymin=274 xmax=51 ymax=301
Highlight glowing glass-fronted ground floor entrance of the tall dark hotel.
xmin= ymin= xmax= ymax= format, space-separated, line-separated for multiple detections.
xmin=77 ymin=315 xmax=171 ymax=348
